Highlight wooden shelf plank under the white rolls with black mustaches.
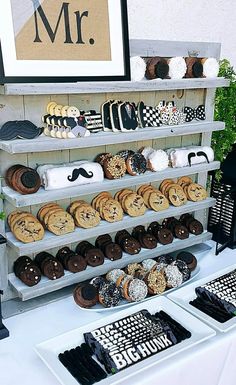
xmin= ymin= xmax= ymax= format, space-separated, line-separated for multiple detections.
xmin=2 ymin=161 xmax=220 ymax=207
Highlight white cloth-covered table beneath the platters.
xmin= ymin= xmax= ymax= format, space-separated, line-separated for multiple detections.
xmin=0 ymin=243 xmax=236 ymax=385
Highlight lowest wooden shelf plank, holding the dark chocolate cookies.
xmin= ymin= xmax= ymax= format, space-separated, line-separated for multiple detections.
xmin=8 ymin=231 xmax=212 ymax=301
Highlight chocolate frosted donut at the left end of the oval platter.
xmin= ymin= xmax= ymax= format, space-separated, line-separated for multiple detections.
xmin=73 ymin=284 xmax=98 ymax=308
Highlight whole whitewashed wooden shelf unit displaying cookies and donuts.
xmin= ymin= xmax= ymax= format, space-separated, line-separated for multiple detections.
xmin=0 ymin=40 xmax=229 ymax=308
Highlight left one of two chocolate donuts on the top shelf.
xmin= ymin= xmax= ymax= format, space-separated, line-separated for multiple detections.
xmin=145 ymin=56 xmax=169 ymax=80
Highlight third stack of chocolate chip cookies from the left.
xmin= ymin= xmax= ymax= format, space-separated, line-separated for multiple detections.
xmin=67 ymin=200 xmax=100 ymax=229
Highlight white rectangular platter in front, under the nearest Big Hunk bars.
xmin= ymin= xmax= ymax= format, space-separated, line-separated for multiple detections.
xmin=35 ymin=296 xmax=216 ymax=385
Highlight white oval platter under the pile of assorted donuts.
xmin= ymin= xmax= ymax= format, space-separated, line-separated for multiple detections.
xmin=78 ymin=266 xmax=200 ymax=313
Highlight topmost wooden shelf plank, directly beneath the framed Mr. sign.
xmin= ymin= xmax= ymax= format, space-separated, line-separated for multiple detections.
xmin=0 ymin=77 xmax=229 ymax=95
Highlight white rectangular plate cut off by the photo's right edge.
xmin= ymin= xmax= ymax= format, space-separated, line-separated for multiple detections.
xmin=167 ymin=264 xmax=236 ymax=332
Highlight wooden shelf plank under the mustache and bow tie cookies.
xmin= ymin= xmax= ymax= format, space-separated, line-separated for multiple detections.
xmin=0 ymin=121 xmax=225 ymax=154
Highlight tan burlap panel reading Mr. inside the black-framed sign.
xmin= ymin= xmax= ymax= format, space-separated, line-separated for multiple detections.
xmin=11 ymin=0 xmax=111 ymax=61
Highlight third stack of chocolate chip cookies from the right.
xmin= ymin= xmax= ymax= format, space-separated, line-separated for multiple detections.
xmin=137 ymin=185 xmax=169 ymax=211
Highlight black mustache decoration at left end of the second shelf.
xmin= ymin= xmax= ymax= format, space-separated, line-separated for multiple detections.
xmin=0 ymin=120 xmax=43 ymax=140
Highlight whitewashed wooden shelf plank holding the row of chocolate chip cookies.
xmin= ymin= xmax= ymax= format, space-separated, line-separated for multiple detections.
xmin=6 ymin=198 xmax=215 ymax=256
